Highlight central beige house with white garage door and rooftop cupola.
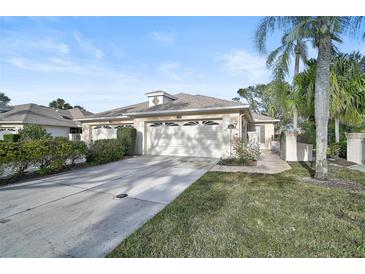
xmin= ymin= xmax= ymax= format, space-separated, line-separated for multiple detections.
xmin=76 ymin=91 xmax=277 ymax=158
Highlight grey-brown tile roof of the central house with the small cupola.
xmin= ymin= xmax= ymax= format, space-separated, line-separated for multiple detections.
xmin=87 ymin=93 xmax=245 ymax=118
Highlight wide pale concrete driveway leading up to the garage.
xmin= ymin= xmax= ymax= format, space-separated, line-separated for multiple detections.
xmin=0 ymin=156 xmax=217 ymax=257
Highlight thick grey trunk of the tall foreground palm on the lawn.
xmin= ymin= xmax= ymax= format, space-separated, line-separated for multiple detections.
xmin=314 ymin=37 xmax=332 ymax=180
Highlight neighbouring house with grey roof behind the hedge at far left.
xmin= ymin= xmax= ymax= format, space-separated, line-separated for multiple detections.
xmin=0 ymin=104 xmax=91 ymax=140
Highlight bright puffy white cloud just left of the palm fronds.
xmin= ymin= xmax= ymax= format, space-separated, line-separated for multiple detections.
xmin=218 ymin=49 xmax=270 ymax=82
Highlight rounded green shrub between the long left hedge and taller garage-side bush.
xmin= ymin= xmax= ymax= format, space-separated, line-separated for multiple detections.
xmin=86 ymin=139 xmax=124 ymax=164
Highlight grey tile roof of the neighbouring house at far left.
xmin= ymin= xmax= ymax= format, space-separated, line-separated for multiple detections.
xmin=0 ymin=104 xmax=77 ymax=127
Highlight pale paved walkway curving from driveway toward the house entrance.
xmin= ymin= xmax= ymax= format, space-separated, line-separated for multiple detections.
xmin=210 ymin=150 xmax=291 ymax=174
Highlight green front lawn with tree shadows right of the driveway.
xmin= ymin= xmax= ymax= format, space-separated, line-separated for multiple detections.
xmin=109 ymin=164 xmax=365 ymax=257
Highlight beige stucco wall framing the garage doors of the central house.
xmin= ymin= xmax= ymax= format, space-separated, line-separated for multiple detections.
xmin=82 ymin=112 xmax=247 ymax=157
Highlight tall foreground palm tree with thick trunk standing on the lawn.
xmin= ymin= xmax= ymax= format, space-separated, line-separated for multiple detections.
xmin=256 ymin=16 xmax=362 ymax=180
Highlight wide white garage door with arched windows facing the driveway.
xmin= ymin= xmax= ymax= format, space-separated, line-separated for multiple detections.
xmin=147 ymin=120 xmax=223 ymax=158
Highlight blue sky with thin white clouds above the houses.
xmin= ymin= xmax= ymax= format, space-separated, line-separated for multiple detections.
xmin=0 ymin=17 xmax=365 ymax=112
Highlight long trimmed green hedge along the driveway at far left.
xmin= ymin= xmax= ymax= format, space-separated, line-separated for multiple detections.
xmin=0 ymin=138 xmax=87 ymax=174
